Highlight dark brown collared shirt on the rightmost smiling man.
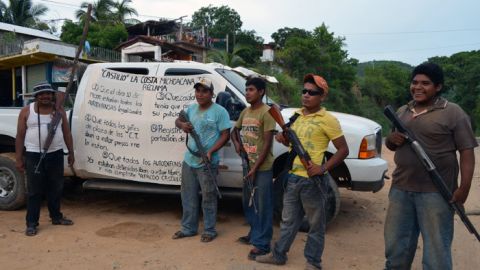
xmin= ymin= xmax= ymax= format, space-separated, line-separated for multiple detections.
xmin=392 ymin=97 xmax=478 ymax=192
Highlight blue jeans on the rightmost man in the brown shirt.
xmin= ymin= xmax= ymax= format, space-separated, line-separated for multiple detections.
xmin=384 ymin=187 xmax=453 ymax=270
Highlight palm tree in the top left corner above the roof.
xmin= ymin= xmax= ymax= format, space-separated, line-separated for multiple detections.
xmin=0 ymin=0 xmax=48 ymax=29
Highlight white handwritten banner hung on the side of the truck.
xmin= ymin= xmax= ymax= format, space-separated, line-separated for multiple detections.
xmin=76 ymin=68 xmax=216 ymax=185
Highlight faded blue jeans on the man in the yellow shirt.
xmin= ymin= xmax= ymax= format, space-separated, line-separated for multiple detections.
xmin=273 ymin=174 xmax=328 ymax=269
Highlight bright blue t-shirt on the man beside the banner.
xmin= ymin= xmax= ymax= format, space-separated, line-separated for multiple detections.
xmin=184 ymin=103 xmax=231 ymax=168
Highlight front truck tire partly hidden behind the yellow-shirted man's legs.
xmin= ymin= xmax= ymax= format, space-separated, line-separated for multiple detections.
xmin=273 ymin=173 xmax=340 ymax=232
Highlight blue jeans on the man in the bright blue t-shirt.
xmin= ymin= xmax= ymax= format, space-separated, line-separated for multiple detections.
xmin=181 ymin=162 xmax=217 ymax=236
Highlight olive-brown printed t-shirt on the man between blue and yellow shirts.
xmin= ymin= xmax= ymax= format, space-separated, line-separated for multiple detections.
xmin=235 ymin=104 xmax=275 ymax=171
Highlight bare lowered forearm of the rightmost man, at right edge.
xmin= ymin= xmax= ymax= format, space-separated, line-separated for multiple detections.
xmin=451 ymin=148 xmax=475 ymax=204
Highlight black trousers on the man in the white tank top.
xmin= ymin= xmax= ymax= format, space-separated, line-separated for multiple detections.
xmin=25 ymin=150 xmax=63 ymax=227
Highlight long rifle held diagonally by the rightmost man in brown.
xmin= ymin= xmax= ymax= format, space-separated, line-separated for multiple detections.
xmin=383 ymin=105 xmax=480 ymax=241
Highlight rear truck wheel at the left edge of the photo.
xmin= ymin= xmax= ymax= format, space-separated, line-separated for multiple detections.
xmin=0 ymin=154 xmax=26 ymax=210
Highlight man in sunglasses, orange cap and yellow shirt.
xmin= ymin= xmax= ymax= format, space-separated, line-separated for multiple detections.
xmin=256 ymin=74 xmax=348 ymax=269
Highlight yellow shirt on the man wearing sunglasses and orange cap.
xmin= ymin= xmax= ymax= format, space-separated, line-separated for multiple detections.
xmin=290 ymin=107 xmax=343 ymax=177
